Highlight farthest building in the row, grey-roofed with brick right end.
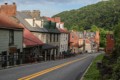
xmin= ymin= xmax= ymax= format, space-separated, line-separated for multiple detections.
xmin=84 ymin=31 xmax=100 ymax=53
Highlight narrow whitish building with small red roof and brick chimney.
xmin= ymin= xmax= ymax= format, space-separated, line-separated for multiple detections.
xmin=55 ymin=20 xmax=69 ymax=57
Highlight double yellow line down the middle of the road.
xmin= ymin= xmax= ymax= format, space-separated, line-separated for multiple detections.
xmin=18 ymin=57 xmax=87 ymax=80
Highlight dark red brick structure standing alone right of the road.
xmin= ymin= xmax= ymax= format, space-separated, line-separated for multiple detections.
xmin=106 ymin=34 xmax=114 ymax=54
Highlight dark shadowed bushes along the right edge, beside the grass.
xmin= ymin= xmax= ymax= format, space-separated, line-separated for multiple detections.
xmin=102 ymin=20 xmax=120 ymax=80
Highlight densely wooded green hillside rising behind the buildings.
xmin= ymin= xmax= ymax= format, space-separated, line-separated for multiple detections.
xmin=53 ymin=0 xmax=120 ymax=30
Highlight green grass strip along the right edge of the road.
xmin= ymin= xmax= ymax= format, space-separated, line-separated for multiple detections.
xmin=83 ymin=54 xmax=104 ymax=80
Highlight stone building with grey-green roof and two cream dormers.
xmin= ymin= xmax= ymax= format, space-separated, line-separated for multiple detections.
xmin=17 ymin=11 xmax=60 ymax=61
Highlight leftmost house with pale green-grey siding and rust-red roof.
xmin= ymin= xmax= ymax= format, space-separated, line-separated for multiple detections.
xmin=0 ymin=13 xmax=23 ymax=67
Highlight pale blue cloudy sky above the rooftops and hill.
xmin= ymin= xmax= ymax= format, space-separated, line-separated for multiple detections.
xmin=0 ymin=0 xmax=101 ymax=17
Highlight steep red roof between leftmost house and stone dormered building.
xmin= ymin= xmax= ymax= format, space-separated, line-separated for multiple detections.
xmin=24 ymin=28 xmax=43 ymax=46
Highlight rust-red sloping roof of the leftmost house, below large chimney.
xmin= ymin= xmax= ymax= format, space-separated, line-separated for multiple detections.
xmin=0 ymin=14 xmax=23 ymax=29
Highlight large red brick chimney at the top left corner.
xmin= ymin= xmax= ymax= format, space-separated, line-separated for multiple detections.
xmin=0 ymin=3 xmax=17 ymax=16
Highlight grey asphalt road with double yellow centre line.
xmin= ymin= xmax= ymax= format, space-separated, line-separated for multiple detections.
xmin=0 ymin=53 xmax=100 ymax=80
